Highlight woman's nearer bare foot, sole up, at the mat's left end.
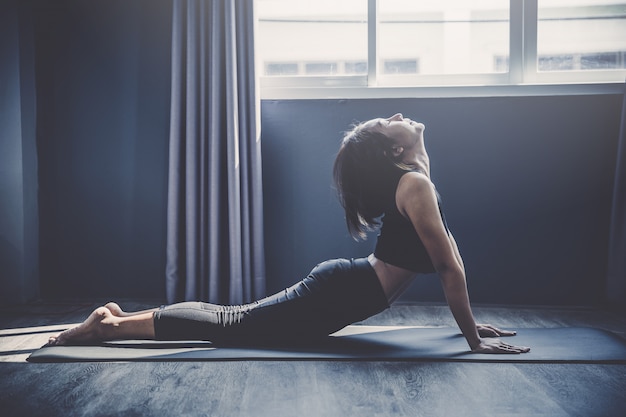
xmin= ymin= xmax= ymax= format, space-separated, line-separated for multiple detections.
xmin=46 ymin=307 xmax=116 ymax=346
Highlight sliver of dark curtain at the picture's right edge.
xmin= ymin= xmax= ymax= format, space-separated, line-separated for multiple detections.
xmin=606 ymin=79 xmax=626 ymax=309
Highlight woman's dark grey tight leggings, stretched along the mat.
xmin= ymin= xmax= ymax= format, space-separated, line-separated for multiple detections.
xmin=154 ymin=258 xmax=389 ymax=345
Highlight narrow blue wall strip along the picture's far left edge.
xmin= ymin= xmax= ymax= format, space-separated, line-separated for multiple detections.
xmin=0 ymin=1 xmax=39 ymax=303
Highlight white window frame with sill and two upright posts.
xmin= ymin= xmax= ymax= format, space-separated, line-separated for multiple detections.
xmin=259 ymin=0 xmax=626 ymax=99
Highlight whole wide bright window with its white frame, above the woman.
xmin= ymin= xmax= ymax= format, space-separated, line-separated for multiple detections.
xmin=256 ymin=0 xmax=626 ymax=96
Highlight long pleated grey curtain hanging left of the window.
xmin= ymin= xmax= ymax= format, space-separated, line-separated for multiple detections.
xmin=166 ymin=0 xmax=265 ymax=304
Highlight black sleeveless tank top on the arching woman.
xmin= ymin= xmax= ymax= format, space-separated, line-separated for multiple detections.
xmin=374 ymin=171 xmax=450 ymax=273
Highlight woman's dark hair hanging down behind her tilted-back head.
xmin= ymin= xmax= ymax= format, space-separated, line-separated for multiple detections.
xmin=333 ymin=121 xmax=408 ymax=240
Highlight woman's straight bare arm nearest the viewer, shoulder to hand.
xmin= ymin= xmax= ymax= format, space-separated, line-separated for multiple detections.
xmin=396 ymin=173 xmax=529 ymax=353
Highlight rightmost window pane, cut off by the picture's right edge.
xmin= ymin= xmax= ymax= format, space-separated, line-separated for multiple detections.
xmin=537 ymin=0 xmax=626 ymax=71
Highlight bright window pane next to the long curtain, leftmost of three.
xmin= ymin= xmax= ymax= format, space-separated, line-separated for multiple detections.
xmin=255 ymin=0 xmax=367 ymax=76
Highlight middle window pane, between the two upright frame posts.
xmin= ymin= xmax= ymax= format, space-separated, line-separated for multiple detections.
xmin=378 ymin=0 xmax=509 ymax=74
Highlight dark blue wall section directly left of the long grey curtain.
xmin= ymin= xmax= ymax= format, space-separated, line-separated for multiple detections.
xmin=35 ymin=0 xmax=171 ymax=298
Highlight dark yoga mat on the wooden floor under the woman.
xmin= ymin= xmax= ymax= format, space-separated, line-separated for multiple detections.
xmin=28 ymin=325 xmax=626 ymax=363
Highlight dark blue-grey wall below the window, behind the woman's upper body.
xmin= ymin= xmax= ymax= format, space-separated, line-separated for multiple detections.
xmin=262 ymin=95 xmax=622 ymax=305
